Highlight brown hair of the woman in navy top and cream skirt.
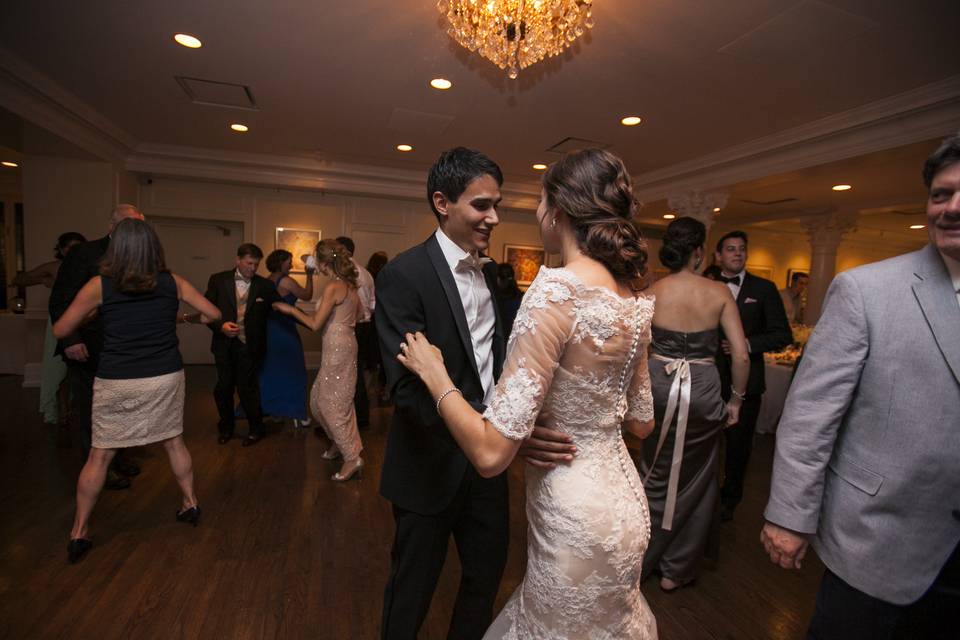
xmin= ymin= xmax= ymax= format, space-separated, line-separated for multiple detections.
xmin=100 ymin=218 xmax=168 ymax=293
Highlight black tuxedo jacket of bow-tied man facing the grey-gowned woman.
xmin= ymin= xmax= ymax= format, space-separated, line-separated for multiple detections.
xmin=717 ymin=271 xmax=793 ymax=398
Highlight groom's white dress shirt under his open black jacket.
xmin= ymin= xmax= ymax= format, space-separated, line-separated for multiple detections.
xmin=435 ymin=229 xmax=497 ymax=404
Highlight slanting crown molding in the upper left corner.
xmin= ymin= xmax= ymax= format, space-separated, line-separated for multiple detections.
xmin=0 ymin=47 xmax=139 ymax=162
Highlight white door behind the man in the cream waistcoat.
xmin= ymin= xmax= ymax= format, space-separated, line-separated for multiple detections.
xmin=149 ymin=216 xmax=243 ymax=364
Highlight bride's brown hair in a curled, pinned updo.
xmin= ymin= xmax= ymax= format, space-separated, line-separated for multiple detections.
xmin=543 ymin=149 xmax=647 ymax=281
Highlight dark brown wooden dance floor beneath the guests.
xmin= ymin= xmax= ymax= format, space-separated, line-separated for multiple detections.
xmin=0 ymin=366 xmax=822 ymax=640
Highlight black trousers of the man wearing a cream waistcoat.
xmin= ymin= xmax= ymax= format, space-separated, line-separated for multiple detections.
xmin=213 ymin=338 xmax=266 ymax=437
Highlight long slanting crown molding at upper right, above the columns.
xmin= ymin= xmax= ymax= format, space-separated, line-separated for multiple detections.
xmin=634 ymin=75 xmax=960 ymax=202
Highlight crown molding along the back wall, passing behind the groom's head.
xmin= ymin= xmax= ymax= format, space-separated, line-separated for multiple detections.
xmin=126 ymin=144 xmax=540 ymax=210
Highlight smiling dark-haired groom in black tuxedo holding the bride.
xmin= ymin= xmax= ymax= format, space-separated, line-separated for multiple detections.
xmin=375 ymin=147 xmax=509 ymax=640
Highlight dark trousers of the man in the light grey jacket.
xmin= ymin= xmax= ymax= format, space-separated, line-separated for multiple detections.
xmin=807 ymin=549 xmax=960 ymax=640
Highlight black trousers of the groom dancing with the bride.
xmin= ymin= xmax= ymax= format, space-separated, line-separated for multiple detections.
xmin=380 ymin=466 xmax=510 ymax=640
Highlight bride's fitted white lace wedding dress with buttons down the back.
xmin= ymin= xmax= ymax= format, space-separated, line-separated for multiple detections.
xmin=484 ymin=267 xmax=657 ymax=640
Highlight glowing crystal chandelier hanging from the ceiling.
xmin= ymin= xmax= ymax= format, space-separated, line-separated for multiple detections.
xmin=437 ymin=0 xmax=593 ymax=78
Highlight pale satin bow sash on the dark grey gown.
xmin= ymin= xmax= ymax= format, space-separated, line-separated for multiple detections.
xmin=643 ymin=353 xmax=714 ymax=531
